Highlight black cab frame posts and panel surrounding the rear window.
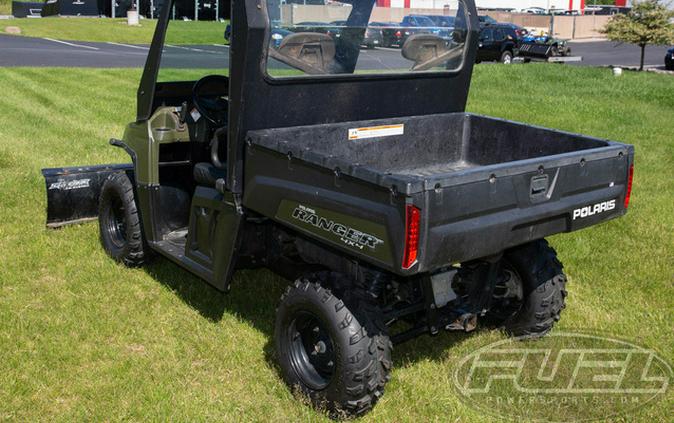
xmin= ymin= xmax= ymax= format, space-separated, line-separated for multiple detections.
xmin=136 ymin=0 xmax=479 ymax=194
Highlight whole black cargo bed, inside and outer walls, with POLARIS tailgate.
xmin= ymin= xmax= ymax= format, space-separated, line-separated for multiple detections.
xmin=244 ymin=113 xmax=633 ymax=271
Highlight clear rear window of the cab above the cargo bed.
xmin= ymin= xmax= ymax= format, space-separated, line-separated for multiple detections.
xmin=267 ymin=0 xmax=468 ymax=78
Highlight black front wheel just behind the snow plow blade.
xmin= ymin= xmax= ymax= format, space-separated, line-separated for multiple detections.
xmin=98 ymin=173 xmax=147 ymax=267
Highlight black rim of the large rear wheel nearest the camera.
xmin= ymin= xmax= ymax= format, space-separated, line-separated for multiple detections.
xmin=287 ymin=311 xmax=337 ymax=389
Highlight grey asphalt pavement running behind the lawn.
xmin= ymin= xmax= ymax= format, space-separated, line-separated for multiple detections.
xmin=0 ymin=35 xmax=666 ymax=69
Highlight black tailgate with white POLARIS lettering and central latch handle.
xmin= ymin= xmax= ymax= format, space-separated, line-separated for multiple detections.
xmin=415 ymin=143 xmax=634 ymax=271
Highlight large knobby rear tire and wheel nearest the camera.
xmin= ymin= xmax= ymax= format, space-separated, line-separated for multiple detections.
xmin=274 ymin=276 xmax=392 ymax=416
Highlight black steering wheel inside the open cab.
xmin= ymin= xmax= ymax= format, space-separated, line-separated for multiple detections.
xmin=192 ymin=75 xmax=229 ymax=126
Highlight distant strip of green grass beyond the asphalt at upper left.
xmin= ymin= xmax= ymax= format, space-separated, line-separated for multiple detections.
xmin=0 ymin=17 xmax=227 ymax=44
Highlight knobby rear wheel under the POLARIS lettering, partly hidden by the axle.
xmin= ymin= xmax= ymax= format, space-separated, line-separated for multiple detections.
xmin=490 ymin=239 xmax=567 ymax=338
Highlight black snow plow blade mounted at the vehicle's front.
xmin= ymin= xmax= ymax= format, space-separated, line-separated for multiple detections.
xmin=42 ymin=163 xmax=133 ymax=229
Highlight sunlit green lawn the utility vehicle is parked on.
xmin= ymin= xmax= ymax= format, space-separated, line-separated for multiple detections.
xmin=0 ymin=64 xmax=674 ymax=422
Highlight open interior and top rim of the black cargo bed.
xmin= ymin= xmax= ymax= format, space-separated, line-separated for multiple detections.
xmin=249 ymin=113 xmax=627 ymax=195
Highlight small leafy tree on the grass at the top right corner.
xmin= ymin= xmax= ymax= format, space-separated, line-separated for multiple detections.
xmin=601 ymin=0 xmax=674 ymax=70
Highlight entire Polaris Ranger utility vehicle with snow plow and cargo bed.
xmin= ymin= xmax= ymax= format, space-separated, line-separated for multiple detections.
xmin=44 ymin=0 xmax=634 ymax=415
